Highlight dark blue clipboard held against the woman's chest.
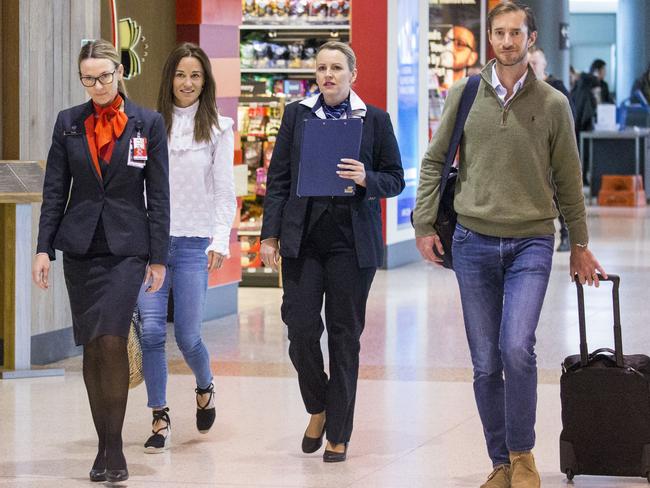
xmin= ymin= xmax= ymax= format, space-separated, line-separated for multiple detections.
xmin=296 ymin=118 xmax=363 ymax=197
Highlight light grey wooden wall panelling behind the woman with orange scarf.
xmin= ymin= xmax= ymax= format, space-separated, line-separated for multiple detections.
xmin=15 ymin=0 xmax=103 ymax=334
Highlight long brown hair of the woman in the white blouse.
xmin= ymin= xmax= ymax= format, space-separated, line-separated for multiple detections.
xmin=158 ymin=42 xmax=219 ymax=142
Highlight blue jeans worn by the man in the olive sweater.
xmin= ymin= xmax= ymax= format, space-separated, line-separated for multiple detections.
xmin=452 ymin=224 xmax=553 ymax=466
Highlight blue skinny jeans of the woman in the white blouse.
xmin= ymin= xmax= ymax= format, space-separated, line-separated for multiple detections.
xmin=138 ymin=236 xmax=212 ymax=409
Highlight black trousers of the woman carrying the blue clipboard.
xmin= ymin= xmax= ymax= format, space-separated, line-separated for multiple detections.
xmin=282 ymin=212 xmax=376 ymax=444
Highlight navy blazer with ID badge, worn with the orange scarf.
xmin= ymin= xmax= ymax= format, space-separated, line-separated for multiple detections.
xmin=37 ymin=98 xmax=169 ymax=264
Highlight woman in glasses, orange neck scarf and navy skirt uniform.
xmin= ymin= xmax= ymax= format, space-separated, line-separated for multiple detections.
xmin=32 ymin=40 xmax=169 ymax=482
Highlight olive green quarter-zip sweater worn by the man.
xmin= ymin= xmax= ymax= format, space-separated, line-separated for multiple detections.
xmin=413 ymin=61 xmax=588 ymax=244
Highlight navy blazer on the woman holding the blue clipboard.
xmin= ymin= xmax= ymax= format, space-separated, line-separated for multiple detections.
xmin=261 ymin=102 xmax=404 ymax=268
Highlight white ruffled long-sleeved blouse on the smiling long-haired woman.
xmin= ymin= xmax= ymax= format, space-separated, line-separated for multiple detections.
xmin=168 ymin=101 xmax=237 ymax=256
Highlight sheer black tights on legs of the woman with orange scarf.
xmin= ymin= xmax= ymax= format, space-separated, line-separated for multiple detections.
xmin=83 ymin=335 xmax=129 ymax=470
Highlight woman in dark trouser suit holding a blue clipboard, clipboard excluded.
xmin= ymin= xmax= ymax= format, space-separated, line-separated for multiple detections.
xmin=261 ymin=41 xmax=404 ymax=462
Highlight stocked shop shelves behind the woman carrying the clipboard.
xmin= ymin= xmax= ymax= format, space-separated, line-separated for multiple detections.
xmin=237 ymin=0 xmax=351 ymax=286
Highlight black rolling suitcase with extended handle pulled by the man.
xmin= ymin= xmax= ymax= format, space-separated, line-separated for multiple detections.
xmin=560 ymin=275 xmax=650 ymax=481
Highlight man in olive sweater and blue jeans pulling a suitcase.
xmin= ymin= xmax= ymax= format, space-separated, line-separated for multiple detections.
xmin=413 ymin=2 xmax=606 ymax=488
